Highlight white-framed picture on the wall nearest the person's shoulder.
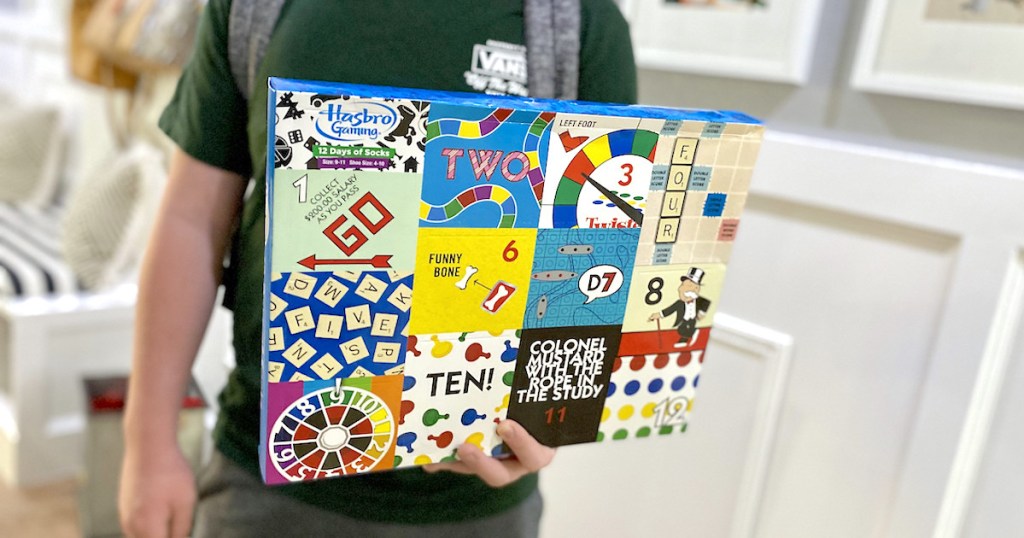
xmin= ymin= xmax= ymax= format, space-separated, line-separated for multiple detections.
xmin=620 ymin=0 xmax=821 ymax=85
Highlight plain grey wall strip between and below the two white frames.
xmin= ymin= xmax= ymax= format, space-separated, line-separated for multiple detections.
xmin=640 ymin=0 xmax=1024 ymax=168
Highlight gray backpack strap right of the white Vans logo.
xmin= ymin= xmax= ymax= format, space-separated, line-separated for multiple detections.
xmin=523 ymin=0 xmax=582 ymax=99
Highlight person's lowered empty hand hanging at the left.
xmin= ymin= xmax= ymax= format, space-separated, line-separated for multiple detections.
xmin=118 ymin=445 xmax=196 ymax=538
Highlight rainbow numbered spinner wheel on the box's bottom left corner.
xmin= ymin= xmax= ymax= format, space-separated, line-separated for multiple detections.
xmin=270 ymin=386 xmax=394 ymax=482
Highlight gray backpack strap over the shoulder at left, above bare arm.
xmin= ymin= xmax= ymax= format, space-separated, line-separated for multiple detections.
xmin=227 ymin=0 xmax=285 ymax=100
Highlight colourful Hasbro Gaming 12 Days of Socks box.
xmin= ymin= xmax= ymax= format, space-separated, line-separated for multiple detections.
xmin=260 ymin=79 xmax=763 ymax=484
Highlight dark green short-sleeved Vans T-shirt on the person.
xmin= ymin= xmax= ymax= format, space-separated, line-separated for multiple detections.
xmin=160 ymin=0 xmax=636 ymax=523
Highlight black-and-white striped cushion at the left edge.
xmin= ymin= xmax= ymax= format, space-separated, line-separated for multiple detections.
xmin=0 ymin=202 xmax=79 ymax=300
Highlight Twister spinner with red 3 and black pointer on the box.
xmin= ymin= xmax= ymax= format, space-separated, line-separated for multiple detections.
xmin=548 ymin=129 xmax=658 ymax=227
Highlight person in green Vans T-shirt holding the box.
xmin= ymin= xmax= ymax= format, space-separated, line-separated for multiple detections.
xmin=119 ymin=0 xmax=636 ymax=537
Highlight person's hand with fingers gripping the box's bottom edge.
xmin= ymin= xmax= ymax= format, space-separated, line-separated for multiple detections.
xmin=424 ymin=420 xmax=555 ymax=488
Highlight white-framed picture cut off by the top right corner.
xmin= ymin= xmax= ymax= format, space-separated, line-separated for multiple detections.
xmin=852 ymin=0 xmax=1024 ymax=110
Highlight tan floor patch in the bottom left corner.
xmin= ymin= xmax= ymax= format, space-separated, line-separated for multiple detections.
xmin=0 ymin=481 xmax=81 ymax=538
